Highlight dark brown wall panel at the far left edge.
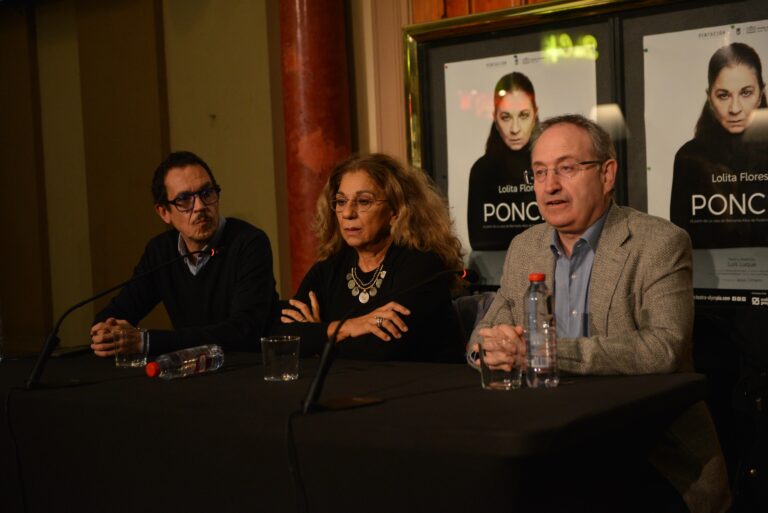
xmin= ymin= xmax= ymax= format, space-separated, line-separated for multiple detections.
xmin=0 ymin=3 xmax=52 ymax=354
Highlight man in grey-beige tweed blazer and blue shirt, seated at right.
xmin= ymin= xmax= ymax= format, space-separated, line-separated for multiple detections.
xmin=468 ymin=115 xmax=730 ymax=512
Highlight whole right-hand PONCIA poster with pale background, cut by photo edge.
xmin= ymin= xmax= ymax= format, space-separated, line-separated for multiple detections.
xmin=643 ymin=20 xmax=768 ymax=303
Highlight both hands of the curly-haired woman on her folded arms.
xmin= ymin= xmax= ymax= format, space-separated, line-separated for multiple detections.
xmin=280 ymin=291 xmax=411 ymax=342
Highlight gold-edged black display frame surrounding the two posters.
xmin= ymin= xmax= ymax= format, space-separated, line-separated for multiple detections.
xmin=403 ymin=0 xmax=768 ymax=300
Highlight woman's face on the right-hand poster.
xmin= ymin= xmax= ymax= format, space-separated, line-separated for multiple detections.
xmin=709 ymin=64 xmax=763 ymax=134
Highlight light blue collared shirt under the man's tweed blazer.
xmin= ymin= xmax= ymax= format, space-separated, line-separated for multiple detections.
xmin=550 ymin=206 xmax=611 ymax=338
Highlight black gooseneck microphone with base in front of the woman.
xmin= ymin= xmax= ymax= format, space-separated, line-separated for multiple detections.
xmin=301 ymin=269 xmax=464 ymax=415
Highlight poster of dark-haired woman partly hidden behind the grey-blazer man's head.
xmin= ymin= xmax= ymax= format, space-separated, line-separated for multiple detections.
xmin=444 ymin=48 xmax=597 ymax=276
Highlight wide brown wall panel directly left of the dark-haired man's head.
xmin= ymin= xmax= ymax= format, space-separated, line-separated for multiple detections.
xmin=77 ymin=0 xmax=169 ymax=316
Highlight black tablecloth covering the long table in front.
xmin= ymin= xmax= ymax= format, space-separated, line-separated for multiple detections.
xmin=0 ymin=353 xmax=706 ymax=512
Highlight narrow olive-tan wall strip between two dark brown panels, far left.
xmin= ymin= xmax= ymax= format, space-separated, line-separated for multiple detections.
xmin=35 ymin=0 xmax=94 ymax=347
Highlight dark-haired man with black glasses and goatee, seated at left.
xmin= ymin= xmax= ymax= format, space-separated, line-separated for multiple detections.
xmin=91 ymin=151 xmax=277 ymax=357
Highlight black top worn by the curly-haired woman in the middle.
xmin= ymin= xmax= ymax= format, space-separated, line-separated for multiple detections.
xmin=278 ymin=244 xmax=464 ymax=362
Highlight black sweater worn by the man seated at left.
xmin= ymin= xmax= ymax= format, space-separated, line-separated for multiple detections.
xmin=94 ymin=218 xmax=277 ymax=354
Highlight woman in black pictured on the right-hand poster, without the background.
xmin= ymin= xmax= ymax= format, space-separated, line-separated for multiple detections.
xmin=669 ymin=43 xmax=768 ymax=249
